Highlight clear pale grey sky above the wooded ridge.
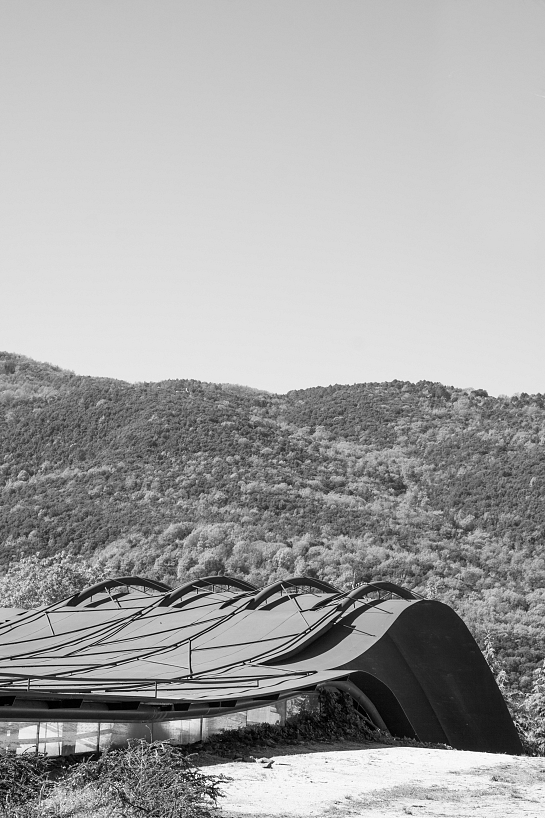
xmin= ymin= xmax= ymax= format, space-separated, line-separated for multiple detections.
xmin=0 ymin=0 xmax=545 ymax=394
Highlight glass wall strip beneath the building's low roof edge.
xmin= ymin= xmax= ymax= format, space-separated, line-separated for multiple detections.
xmin=0 ymin=694 xmax=318 ymax=756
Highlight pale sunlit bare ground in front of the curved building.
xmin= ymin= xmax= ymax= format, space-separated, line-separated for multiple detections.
xmin=199 ymin=744 xmax=545 ymax=818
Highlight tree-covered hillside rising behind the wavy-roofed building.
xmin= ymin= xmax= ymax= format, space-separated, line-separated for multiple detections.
xmin=0 ymin=353 xmax=545 ymax=688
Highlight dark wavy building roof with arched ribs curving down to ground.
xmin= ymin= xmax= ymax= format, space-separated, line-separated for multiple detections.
xmin=0 ymin=576 xmax=522 ymax=753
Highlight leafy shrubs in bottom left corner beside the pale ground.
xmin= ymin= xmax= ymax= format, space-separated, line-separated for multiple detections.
xmin=0 ymin=741 xmax=225 ymax=818
